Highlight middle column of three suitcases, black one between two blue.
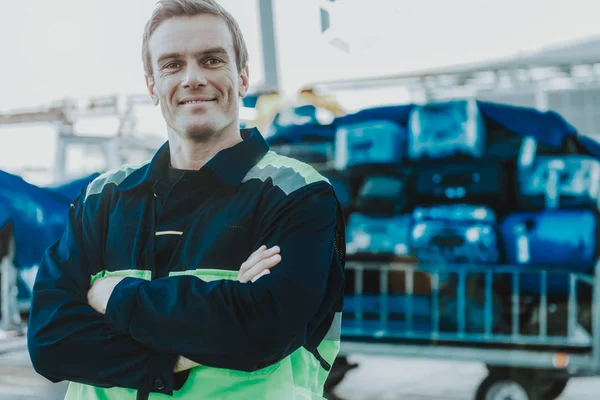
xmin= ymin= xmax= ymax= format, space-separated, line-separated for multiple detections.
xmin=408 ymin=101 xmax=509 ymax=270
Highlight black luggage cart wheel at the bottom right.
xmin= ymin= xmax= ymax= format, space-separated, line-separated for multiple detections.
xmin=475 ymin=365 xmax=568 ymax=400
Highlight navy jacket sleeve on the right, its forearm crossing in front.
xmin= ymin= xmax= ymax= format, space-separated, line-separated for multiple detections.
xmin=106 ymin=183 xmax=343 ymax=371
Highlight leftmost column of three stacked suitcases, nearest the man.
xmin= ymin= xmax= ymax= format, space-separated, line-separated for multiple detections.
xmin=334 ymin=107 xmax=411 ymax=261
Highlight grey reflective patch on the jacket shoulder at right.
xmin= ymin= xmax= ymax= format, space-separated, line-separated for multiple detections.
xmin=242 ymin=151 xmax=329 ymax=195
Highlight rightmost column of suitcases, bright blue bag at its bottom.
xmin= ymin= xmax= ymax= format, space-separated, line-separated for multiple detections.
xmin=501 ymin=154 xmax=600 ymax=296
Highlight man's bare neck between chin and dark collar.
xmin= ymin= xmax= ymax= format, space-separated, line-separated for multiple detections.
xmin=168 ymin=125 xmax=242 ymax=170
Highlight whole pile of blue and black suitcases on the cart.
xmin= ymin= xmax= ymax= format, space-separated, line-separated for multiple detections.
xmin=335 ymin=100 xmax=600 ymax=331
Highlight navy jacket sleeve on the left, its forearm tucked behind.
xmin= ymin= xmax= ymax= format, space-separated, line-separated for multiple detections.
xmin=27 ymin=191 xmax=176 ymax=394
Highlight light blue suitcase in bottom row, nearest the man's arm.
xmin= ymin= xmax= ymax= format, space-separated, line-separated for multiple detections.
xmin=346 ymin=213 xmax=412 ymax=260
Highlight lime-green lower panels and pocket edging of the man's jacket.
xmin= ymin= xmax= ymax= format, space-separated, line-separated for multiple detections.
xmin=77 ymin=269 xmax=342 ymax=400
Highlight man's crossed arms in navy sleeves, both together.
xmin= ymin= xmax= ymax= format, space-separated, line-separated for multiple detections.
xmin=28 ymin=185 xmax=338 ymax=394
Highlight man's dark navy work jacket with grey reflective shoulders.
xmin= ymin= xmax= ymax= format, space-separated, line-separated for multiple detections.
xmin=28 ymin=130 xmax=345 ymax=394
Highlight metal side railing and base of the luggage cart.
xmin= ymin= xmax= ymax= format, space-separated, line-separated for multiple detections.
xmin=341 ymin=261 xmax=600 ymax=396
